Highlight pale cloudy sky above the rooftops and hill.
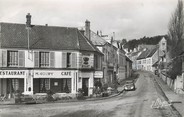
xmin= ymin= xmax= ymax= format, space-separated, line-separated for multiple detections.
xmin=0 ymin=0 xmax=178 ymax=40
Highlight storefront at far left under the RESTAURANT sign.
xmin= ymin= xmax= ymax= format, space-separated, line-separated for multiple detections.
xmin=0 ymin=70 xmax=27 ymax=98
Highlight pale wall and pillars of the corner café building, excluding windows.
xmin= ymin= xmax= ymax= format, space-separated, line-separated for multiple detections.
xmin=0 ymin=49 xmax=102 ymax=94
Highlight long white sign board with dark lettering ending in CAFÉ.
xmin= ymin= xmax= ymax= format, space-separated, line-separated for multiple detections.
xmin=34 ymin=70 xmax=74 ymax=78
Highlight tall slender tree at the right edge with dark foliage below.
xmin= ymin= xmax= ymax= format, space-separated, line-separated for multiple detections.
xmin=168 ymin=0 xmax=184 ymax=79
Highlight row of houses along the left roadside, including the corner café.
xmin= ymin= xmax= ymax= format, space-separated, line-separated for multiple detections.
xmin=0 ymin=14 xmax=132 ymax=96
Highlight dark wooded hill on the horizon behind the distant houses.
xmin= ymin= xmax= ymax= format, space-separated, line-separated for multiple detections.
xmin=124 ymin=35 xmax=168 ymax=50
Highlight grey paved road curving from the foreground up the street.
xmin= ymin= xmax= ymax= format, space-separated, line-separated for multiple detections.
xmin=0 ymin=72 xmax=180 ymax=117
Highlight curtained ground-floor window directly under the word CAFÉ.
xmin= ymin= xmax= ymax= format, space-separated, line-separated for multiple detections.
xmin=62 ymin=78 xmax=71 ymax=93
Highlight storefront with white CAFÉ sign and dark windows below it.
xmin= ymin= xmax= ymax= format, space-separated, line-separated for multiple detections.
xmin=33 ymin=70 xmax=78 ymax=93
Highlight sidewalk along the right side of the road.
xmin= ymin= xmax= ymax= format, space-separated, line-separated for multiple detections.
xmin=155 ymin=73 xmax=184 ymax=117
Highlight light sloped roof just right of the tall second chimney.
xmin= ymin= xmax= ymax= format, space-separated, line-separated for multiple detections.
xmin=91 ymin=31 xmax=108 ymax=45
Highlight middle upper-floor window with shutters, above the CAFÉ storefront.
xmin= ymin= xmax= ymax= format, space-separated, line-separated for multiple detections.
xmin=40 ymin=52 xmax=49 ymax=67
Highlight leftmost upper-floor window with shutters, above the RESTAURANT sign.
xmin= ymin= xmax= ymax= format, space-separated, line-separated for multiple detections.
xmin=7 ymin=51 xmax=18 ymax=67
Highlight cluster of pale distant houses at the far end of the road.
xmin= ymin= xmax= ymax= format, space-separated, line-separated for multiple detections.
xmin=128 ymin=37 xmax=167 ymax=72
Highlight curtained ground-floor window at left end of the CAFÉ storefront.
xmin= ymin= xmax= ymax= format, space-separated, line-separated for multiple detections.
xmin=40 ymin=79 xmax=50 ymax=93
